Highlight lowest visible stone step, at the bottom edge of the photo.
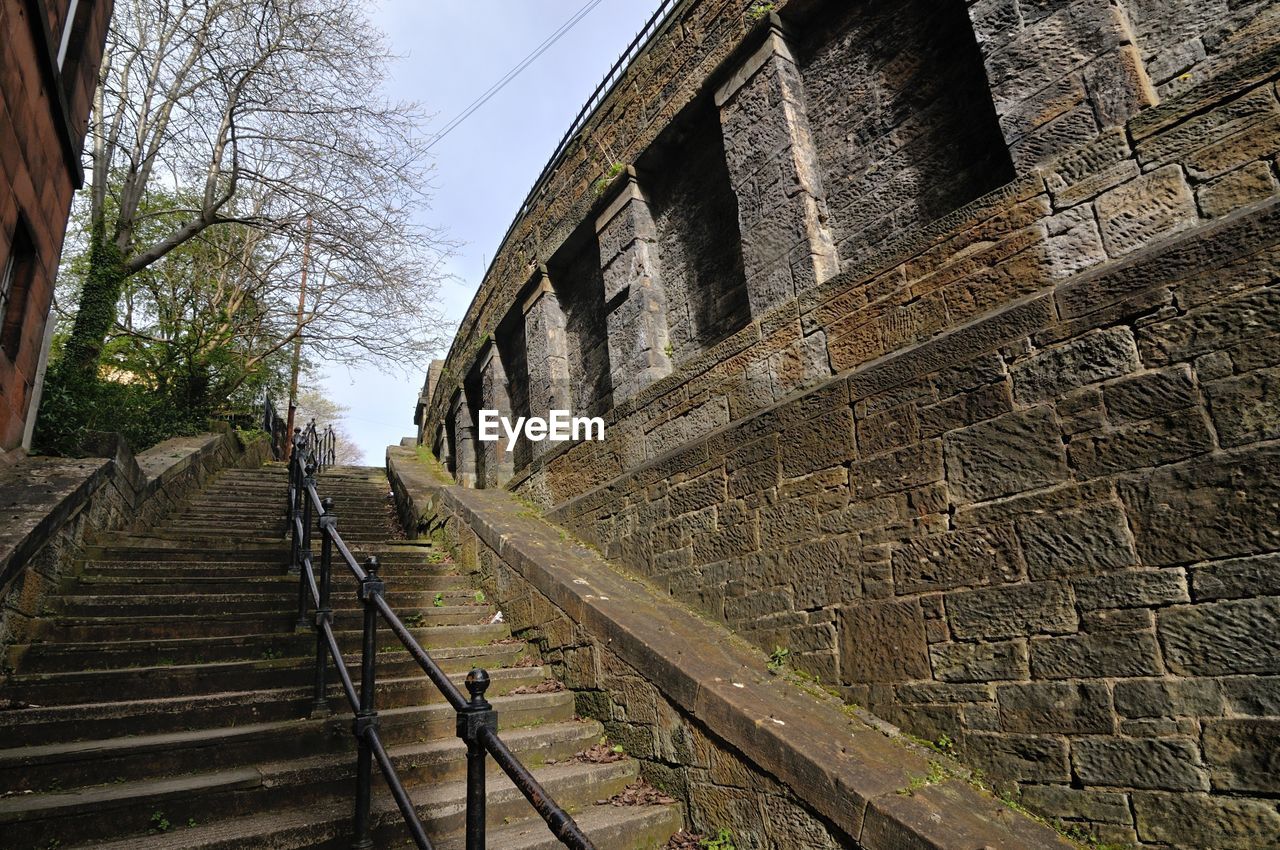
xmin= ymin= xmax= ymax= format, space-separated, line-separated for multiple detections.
xmin=67 ymin=771 xmax=684 ymax=850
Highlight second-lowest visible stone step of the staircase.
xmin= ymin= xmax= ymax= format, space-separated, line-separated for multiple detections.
xmin=0 ymin=727 xmax=637 ymax=847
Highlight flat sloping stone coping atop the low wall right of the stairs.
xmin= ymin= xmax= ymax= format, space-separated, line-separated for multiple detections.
xmin=387 ymin=447 xmax=1074 ymax=850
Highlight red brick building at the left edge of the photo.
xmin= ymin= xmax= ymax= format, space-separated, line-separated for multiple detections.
xmin=0 ymin=0 xmax=113 ymax=457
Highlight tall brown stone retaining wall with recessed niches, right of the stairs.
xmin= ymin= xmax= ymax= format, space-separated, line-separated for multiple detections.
xmin=422 ymin=0 xmax=1280 ymax=849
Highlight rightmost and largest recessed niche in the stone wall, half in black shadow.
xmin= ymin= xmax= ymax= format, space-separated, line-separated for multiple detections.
xmin=797 ymin=0 xmax=1014 ymax=261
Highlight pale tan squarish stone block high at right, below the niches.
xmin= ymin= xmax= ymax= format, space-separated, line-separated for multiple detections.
xmin=1096 ymin=165 xmax=1199 ymax=257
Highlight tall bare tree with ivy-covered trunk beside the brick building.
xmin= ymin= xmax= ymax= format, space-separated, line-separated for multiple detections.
xmin=60 ymin=0 xmax=448 ymax=379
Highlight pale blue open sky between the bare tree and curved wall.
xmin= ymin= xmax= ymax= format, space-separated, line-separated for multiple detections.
xmin=323 ymin=0 xmax=659 ymax=466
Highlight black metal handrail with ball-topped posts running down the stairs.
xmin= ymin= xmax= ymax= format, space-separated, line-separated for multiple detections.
xmin=288 ymin=435 xmax=595 ymax=850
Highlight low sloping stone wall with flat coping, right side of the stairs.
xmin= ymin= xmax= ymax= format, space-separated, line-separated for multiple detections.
xmin=387 ymin=447 xmax=1071 ymax=850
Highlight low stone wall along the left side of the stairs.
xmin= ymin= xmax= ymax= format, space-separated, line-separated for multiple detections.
xmin=0 ymin=425 xmax=271 ymax=650
